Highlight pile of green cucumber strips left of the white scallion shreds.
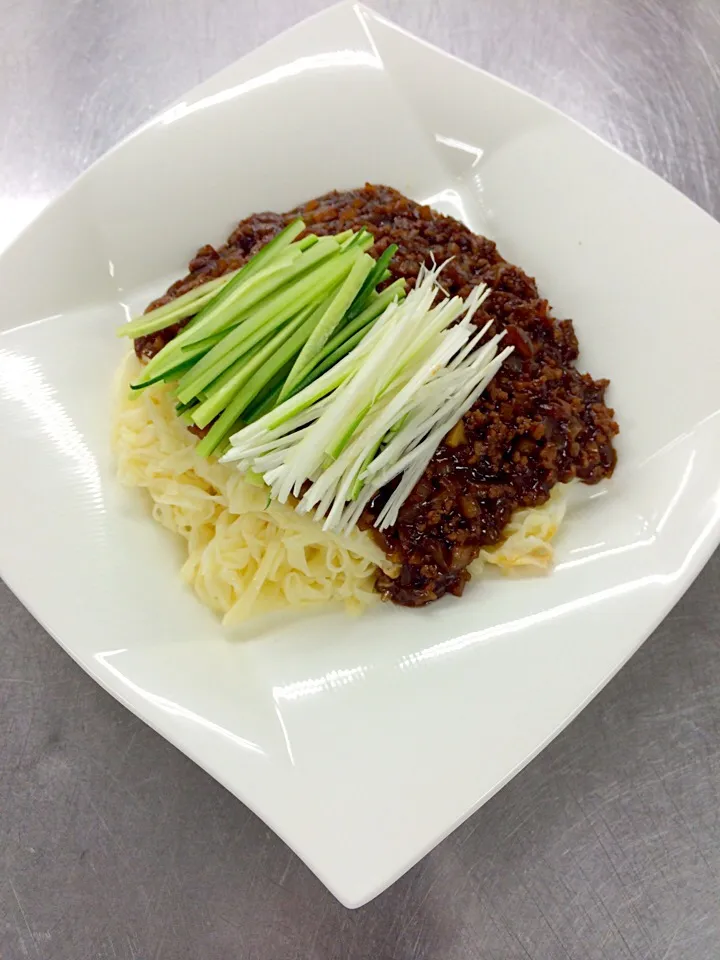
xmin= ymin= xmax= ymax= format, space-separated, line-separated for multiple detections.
xmin=118 ymin=220 xmax=405 ymax=466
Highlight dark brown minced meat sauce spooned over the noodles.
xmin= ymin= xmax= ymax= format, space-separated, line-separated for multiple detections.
xmin=135 ymin=184 xmax=618 ymax=606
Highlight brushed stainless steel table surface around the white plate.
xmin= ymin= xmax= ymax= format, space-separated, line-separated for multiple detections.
xmin=0 ymin=0 xmax=720 ymax=960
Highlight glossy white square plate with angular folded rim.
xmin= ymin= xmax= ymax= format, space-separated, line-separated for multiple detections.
xmin=0 ymin=4 xmax=720 ymax=906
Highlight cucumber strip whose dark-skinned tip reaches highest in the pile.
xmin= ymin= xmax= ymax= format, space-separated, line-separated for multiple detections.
xmin=134 ymin=220 xmax=305 ymax=379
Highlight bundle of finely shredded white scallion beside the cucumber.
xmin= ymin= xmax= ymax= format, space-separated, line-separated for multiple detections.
xmin=223 ymin=267 xmax=512 ymax=532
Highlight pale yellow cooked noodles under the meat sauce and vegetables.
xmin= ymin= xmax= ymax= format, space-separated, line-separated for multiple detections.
xmin=113 ymin=355 xmax=565 ymax=625
